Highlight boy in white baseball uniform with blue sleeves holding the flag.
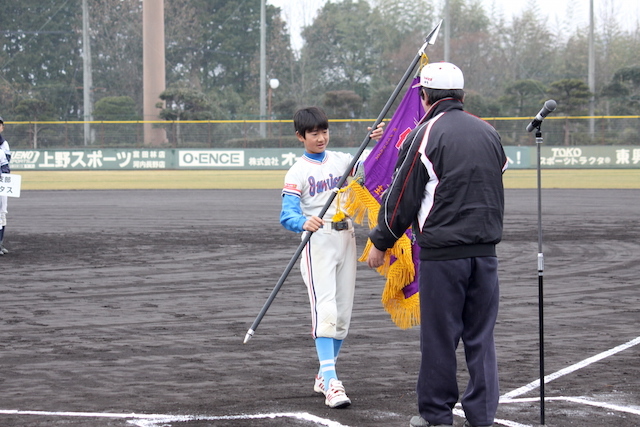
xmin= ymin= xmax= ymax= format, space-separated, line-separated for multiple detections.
xmin=280 ymin=107 xmax=384 ymax=408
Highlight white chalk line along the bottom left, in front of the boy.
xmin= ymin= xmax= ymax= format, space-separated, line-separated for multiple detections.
xmin=0 ymin=409 xmax=349 ymax=427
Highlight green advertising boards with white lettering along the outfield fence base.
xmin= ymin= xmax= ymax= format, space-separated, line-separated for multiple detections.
xmin=11 ymin=144 xmax=640 ymax=170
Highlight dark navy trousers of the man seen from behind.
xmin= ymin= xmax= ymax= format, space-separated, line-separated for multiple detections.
xmin=417 ymin=257 xmax=499 ymax=426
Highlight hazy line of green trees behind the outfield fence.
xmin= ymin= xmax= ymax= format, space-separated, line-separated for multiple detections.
xmin=0 ymin=0 xmax=640 ymax=146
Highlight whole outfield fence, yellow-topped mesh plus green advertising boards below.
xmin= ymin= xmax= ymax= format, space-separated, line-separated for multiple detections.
xmin=3 ymin=116 xmax=640 ymax=171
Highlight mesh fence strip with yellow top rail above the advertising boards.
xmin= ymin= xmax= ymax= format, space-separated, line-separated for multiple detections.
xmin=3 ymin=116 xmax=640 ymax=149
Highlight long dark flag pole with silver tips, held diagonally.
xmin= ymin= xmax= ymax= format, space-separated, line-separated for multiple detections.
xmin=244 ymin=21 xmax=442 ymax=344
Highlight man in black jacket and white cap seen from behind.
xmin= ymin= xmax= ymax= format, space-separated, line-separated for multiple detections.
xmin=367 ymin=62 xmax=507 ymax=427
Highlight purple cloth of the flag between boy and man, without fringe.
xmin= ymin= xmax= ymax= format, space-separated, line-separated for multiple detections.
xmin=364 ymin=77 xmax=425 ymax=298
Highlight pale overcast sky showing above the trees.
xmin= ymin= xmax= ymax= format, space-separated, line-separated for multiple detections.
xmin=267 ymin=0 xmax=640 ymax=50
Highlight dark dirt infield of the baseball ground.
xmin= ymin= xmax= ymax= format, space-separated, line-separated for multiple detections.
xmin=0 ymin=190 xmax=640 ymax=427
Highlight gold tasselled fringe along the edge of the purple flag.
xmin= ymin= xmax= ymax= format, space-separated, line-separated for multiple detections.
xmin=338 ymin=179 xmax=420 ymax=329
